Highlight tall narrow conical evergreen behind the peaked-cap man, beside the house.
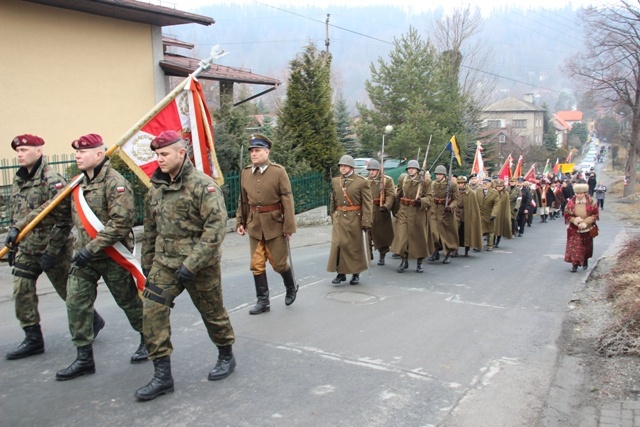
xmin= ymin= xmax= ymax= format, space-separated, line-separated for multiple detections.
xmin=273 ymin=43 xmax=343 ymax=177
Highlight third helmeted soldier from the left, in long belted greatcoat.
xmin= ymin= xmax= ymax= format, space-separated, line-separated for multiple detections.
xmin=391 ymin=160 xmax=433 ymax=273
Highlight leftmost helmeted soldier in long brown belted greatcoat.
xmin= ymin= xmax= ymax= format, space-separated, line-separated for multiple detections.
xmin=327 ymin=155 xmax=373 ymax=285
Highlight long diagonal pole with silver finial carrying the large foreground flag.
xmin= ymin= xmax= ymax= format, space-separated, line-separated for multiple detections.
xmin=0 ymin=45 xmax=228 ymax=258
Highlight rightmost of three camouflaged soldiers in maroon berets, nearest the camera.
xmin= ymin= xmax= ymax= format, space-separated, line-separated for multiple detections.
xmin=135 ymin=131 xmax=236 ymax=401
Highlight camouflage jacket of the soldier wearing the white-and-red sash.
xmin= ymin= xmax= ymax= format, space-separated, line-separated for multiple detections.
xmin=73 ymin=159 xmax=134 ymax=258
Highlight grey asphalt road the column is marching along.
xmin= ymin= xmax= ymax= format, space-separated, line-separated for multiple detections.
xmin=0 ymin=195 xmax=623 ymax=426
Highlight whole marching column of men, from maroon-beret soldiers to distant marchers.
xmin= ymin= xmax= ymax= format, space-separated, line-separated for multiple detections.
xmin=5 ymin=131 xmax=586 ymax=401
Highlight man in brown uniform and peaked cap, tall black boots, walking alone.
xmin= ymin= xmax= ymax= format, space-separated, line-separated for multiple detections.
xmin=236 ymin=134 xmax=298 ymax=314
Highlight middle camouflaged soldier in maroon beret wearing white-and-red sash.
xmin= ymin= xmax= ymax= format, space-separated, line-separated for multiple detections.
xmin=56 ymin=134 xmax=147 ymax=381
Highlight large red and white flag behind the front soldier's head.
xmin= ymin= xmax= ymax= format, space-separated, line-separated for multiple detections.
xmin=120 ymin=77 xmax=224 ymax=185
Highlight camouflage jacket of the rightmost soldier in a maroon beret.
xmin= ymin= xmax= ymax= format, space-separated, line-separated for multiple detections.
xmin=142 ymin=159 xmax=227 ymax=273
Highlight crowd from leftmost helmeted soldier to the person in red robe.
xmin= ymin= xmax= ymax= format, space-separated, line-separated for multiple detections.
xmin=327 ymin=155 xmax=606 ymax=285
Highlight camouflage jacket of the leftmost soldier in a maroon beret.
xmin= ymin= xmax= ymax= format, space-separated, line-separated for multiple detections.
xmin=11 ymin=157 xmax=71 ymax=256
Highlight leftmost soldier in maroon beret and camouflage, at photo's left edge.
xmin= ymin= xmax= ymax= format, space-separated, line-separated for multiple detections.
xmin=6 ymin=135 xmax=104 ymax=360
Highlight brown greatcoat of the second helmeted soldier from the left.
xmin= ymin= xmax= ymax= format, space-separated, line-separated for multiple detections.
xmin=367 ymin=176 xmax=395 ymax=256
